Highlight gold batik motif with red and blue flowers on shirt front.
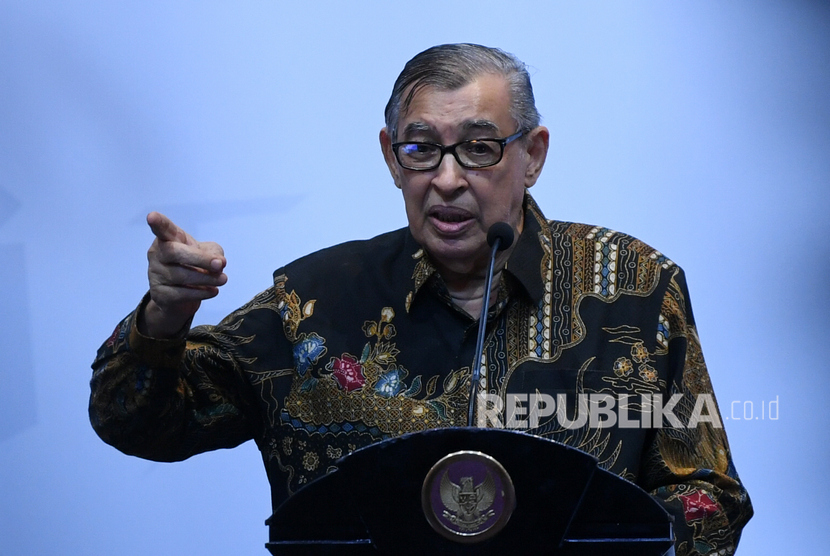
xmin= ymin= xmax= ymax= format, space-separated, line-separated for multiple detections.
xmin=277 ymin=274 xmax=470 ymax=436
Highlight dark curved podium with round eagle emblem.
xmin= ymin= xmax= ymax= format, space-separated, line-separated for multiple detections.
xmin=266 ymin=428 xmax=674 ymax=556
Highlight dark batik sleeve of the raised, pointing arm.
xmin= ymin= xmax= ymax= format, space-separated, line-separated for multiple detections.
xmin=89 ymin=296 xmax=270 ymax=461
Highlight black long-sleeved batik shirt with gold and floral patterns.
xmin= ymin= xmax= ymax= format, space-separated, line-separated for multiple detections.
xmin=90 ymin=196 xmax=752 ymax=554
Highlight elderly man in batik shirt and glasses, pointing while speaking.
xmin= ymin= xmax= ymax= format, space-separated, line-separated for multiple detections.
xmin=90 ymin=45 xmax=752 ymax=554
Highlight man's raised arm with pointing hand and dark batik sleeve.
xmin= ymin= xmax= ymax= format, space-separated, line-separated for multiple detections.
xmin=90 ymin=212 xmax=251 ymax=461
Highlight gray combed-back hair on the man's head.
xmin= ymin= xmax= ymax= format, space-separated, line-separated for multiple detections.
xmin=385 ymin=43 xmax=540 ymax=141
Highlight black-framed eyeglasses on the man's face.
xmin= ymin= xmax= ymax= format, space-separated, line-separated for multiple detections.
xmin=392 ymin=131 xmax=525 ymax=171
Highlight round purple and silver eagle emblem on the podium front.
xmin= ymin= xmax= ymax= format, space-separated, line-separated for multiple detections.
xmin=421 ymin=451 xmax=516 ymax=543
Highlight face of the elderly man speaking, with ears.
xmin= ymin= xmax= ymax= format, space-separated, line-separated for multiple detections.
xmin=380 ymin=74 xmax=548 ymax=274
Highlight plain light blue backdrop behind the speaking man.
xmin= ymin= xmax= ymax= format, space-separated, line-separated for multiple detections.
xmin=0 ymin=0 xmax=830 ymax=556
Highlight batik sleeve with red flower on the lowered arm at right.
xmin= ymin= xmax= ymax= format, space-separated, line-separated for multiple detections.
xmin=641 ymin=270 xmax=753 ymax=556
